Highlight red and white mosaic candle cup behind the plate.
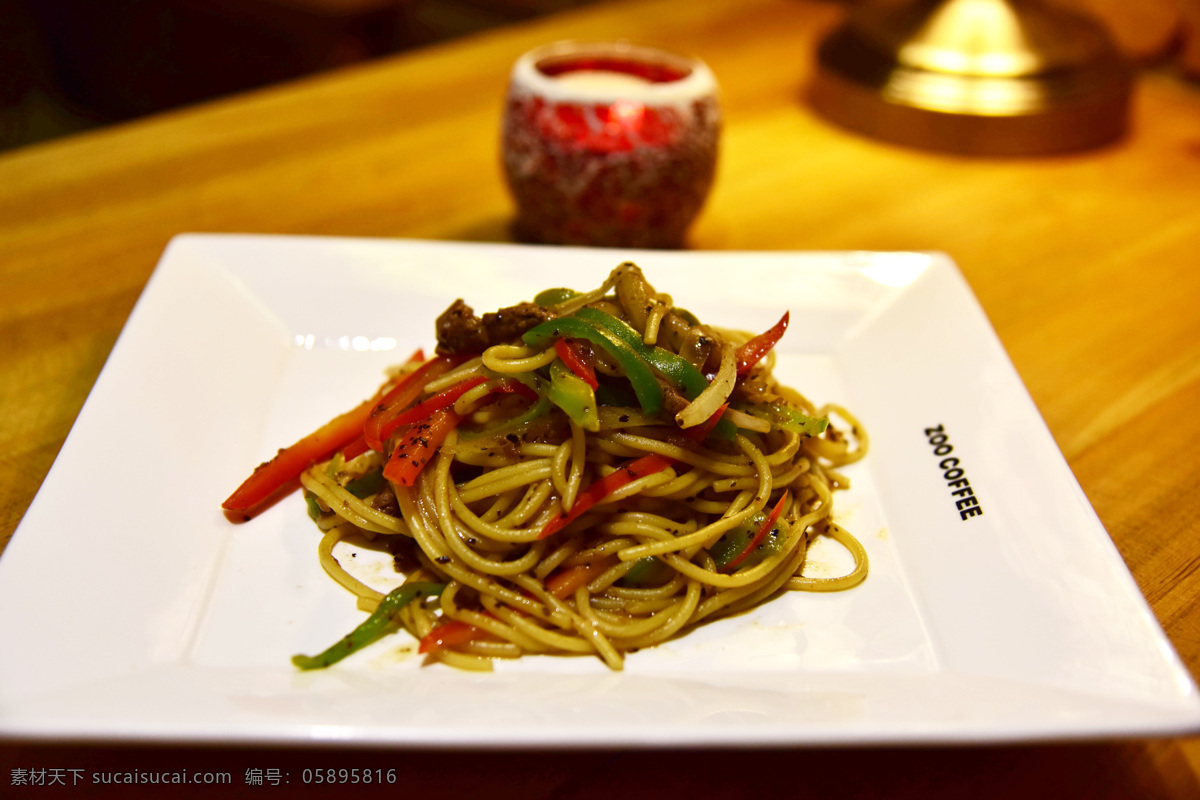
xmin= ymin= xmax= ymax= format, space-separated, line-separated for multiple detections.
xmin=503 ymin=42 xmax=721 ymax=247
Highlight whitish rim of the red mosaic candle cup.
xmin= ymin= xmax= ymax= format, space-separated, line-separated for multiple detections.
xmin=510 ymin=40 xmax=716 ymax=106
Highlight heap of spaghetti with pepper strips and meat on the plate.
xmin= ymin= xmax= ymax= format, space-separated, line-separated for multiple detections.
xmin=296 ymin=263 xmax=866 ymax=669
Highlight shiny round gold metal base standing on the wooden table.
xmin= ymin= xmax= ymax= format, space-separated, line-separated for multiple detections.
xmin=809 ymin=0 xmax=1133 ymax=156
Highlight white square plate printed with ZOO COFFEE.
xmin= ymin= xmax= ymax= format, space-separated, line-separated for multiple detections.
xmin=0 ymin=235 xmax=1200 ymax=747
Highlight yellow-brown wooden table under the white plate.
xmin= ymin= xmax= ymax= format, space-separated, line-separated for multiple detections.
xmin=0 ymin=0 xmax=1200 ymax=800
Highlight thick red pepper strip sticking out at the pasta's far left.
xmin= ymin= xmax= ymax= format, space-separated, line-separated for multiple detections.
xmin=221 ymin=398 xmax=377 ymax=519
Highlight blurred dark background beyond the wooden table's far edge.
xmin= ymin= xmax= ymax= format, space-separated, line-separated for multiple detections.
xmin=0 ymin=0 xmax=1200 ymax=150
